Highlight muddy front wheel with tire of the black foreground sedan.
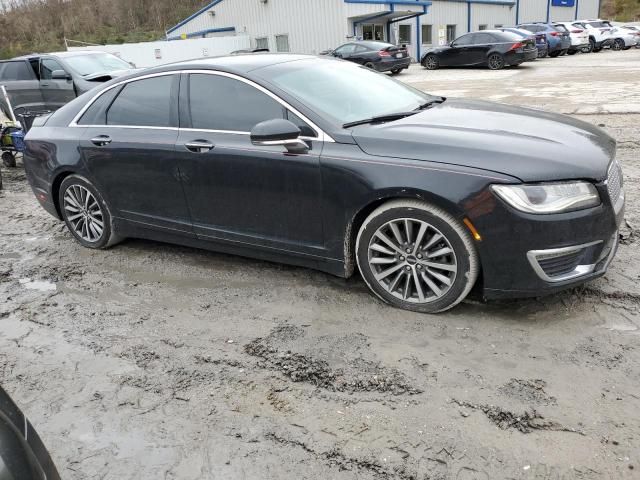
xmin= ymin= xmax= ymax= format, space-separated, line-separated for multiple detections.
xmin=356 ymin=200 xmax=480 ymax=313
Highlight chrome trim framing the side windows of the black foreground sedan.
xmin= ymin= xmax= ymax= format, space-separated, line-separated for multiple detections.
xmin=68 ymin=69 xmax=335 ymax=143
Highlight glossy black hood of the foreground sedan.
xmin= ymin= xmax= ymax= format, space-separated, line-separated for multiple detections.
xmin=352 ymin=99 xmax=616 ymax=182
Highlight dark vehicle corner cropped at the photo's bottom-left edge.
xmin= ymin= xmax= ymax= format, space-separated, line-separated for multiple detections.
xmin=0 ymin=387 xmax=60 ymax=480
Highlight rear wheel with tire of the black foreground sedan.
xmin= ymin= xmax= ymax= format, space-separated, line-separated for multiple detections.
xmin=58 ymin=175 xmax=120 ymax=249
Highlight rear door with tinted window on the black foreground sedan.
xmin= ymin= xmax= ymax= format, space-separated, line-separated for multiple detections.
xmin=78 ymin=74 xmax=192 ymax=234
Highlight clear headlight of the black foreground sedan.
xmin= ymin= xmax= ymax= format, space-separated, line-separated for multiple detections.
xmin=491 ymin=182 xmax=600 ymax=213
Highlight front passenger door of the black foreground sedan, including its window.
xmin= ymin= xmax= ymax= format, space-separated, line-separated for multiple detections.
xmin=176 ymin=73 xmax=324 ymax=254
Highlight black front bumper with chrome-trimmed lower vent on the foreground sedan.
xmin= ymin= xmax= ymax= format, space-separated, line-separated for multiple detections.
xmin=468 ymin=170 xmax=624 ymax=299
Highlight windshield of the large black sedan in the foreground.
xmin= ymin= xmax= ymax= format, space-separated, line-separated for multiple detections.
xmin=259 ymin=60 xmax=439 ymax=124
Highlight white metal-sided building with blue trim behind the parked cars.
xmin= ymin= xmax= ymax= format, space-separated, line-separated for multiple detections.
xmin=167 ymin=0 xmax=600 ymax=59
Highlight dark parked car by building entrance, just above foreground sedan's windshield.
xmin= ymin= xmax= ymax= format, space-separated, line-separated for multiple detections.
xmin=325 ymin=40 xmax=411 ymax=75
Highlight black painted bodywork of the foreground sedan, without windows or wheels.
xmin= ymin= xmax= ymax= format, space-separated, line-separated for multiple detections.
xmin=24 ymin=54 xmax=621 ymax=296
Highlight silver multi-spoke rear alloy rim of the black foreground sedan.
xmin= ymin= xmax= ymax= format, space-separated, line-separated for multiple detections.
xmin=63 ymin=185 xmax=104 ymax=243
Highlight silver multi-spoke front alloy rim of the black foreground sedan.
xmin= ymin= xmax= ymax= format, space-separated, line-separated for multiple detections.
xmin=368 ymin=218 xmax=458 ymax=304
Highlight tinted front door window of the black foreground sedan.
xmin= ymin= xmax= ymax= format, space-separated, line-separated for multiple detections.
xmin=189 ymin=73 xmax=284 ymax=132
